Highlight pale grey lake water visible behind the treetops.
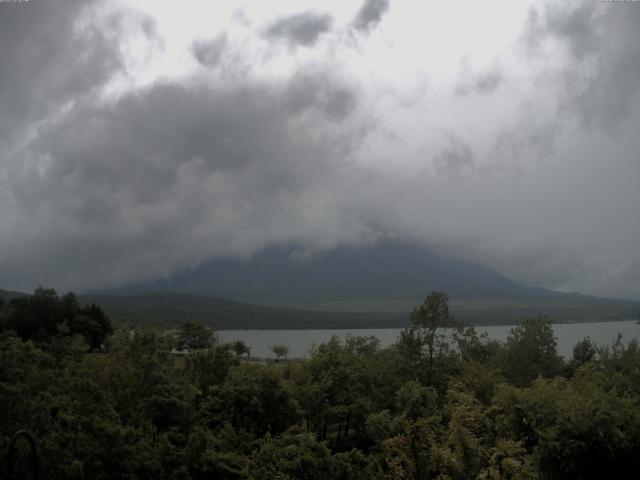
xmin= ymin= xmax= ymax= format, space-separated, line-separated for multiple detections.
xmin=217 ymin=320 xmax=640 ymax=358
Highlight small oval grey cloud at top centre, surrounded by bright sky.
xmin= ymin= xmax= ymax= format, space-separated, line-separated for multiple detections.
xmin=265 ymin=11 xmax=333 ymax=47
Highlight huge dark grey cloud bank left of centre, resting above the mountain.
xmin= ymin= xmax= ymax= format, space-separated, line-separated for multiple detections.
xmin=0 ymin=77 xmax=374 ymax=287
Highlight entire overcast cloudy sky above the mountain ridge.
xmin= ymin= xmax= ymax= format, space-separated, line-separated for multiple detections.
xmin=0 ymin=0 xmax=640 ymax=299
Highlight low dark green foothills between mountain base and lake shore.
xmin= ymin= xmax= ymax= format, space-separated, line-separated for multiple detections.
xmin=79 ymin=292 xmax=640 ymax=329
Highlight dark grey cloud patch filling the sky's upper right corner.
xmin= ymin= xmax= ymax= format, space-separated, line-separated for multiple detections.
xmin=525 ymin=1 xmax=640 ymax=131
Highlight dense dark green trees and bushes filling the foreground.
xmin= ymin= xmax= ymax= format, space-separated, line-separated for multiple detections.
xmin=0 ymin=290 xmax=640 ymax=480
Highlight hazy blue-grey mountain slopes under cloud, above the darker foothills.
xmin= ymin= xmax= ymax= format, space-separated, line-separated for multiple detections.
xmin=107 ymin=242 xmax=562 ymax=304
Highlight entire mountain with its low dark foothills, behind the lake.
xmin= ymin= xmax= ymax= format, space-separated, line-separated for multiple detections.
xmin=82 ymin=242 xmax=640 ymax=328
